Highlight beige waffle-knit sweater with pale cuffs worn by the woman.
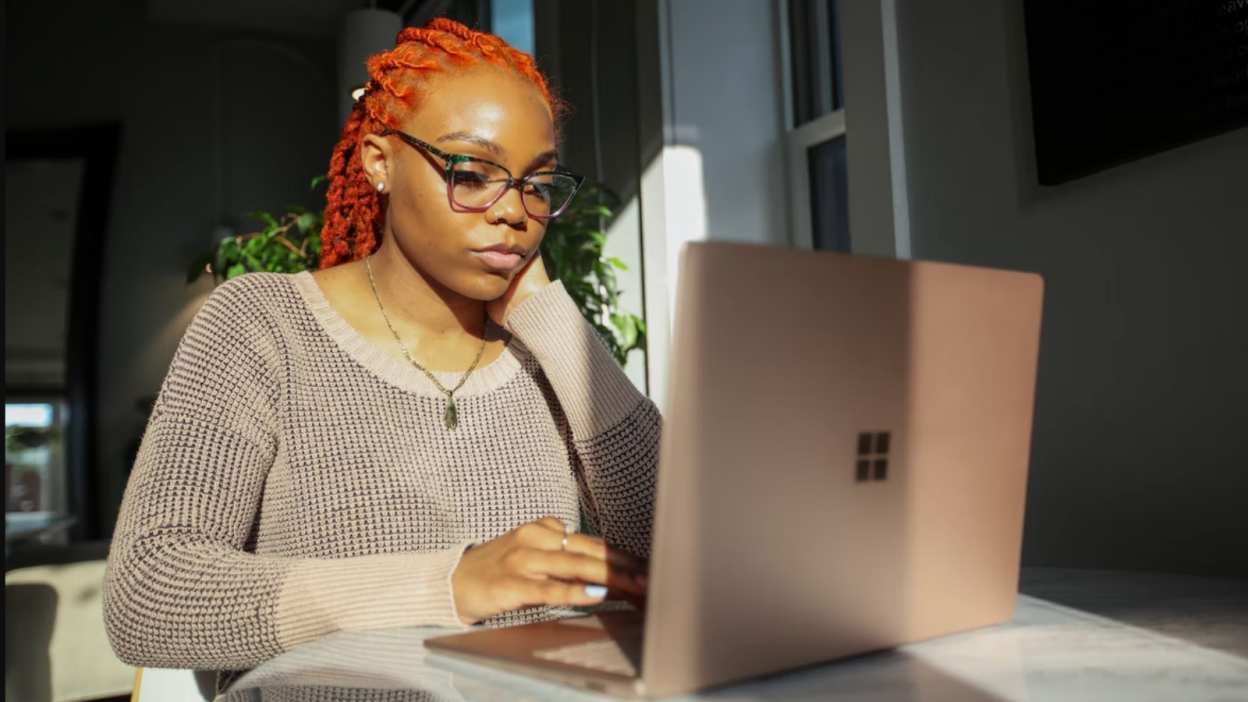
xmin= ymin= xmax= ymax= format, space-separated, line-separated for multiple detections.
xmin=104 ymin=274 xmax=660 ymax=670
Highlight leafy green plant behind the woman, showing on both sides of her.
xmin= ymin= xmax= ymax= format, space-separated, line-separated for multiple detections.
xmin=186 ymin=176 xmax=645 ymax=366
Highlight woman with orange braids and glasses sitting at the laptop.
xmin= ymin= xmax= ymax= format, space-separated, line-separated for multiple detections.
xmin=105 ymin=20 xmax=660 ymax=670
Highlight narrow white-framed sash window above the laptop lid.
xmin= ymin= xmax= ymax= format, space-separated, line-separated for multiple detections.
xmin=780 ymin=0 xmax=850 ymax=252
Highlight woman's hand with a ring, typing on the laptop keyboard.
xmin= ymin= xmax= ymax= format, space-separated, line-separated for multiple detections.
xmin=451 ymin=517 xmax=646 ymax=625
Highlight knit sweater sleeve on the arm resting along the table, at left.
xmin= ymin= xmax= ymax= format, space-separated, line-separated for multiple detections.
xmin=104 ymin=276 xmax=468 ymax=670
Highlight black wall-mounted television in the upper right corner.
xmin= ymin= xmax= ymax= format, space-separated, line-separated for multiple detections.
xmin=1023 ymin=0 xmax=1248 ymax=185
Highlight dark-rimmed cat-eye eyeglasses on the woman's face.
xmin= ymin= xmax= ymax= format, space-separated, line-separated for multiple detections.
xmin=382 ymin=129 xmax=585 ymax=220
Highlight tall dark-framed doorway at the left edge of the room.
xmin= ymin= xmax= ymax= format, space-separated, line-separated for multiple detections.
xmin=5 ymin=124 xmax=121 ymax=541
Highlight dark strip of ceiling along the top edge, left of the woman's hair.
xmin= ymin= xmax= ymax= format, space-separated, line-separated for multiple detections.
xmin=147 ymin=0 xmax=419 ymax=39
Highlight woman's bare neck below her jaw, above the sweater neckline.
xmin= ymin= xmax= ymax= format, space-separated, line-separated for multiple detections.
xmin=371 ymin=239 xmax=485 ymax=339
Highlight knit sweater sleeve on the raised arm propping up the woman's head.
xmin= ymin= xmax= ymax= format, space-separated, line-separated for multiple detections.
xmin=507 ymin=282 xmax=663 ymax=557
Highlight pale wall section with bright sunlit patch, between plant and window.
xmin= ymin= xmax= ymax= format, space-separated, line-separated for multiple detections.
xmin=636 ymin=0 xmax=789 ymax=407
